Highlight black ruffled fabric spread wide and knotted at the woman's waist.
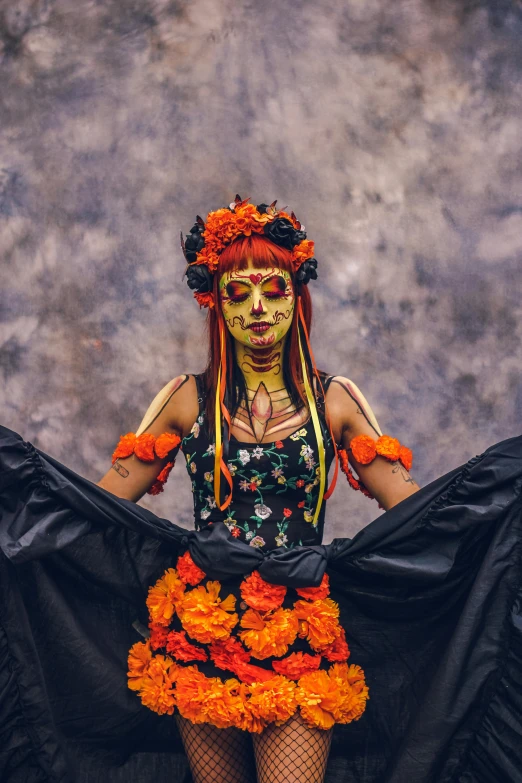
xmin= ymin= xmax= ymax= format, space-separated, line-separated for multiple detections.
xmin=0 ymin=426 xmax=522 ymax=783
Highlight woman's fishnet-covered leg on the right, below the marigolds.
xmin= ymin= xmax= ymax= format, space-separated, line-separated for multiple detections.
xmin=252 ymin=713 xmax=333 ymax=783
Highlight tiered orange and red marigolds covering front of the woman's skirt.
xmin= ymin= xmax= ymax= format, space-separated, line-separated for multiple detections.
xmin=127 ymin=552 xmax=369 ymax=733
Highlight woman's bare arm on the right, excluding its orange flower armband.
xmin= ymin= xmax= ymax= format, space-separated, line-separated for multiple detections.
xmin=326 ymin=375 xmax=420 ymax=510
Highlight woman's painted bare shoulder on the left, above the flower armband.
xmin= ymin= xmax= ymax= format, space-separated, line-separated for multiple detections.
xmin=136 ymin=373 xmax=199 ymax=437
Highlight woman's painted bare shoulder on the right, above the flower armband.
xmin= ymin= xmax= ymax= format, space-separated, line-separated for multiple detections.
xmin=326 ymin=375 xmax=382 ymax=440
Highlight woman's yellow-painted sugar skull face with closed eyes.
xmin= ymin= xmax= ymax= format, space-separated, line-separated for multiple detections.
xmin=219 ymin=260 xmax=295 ymax=348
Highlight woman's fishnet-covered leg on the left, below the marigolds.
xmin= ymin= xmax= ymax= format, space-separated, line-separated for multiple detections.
xmin=175 ymin=714 xmax=256 ymax=783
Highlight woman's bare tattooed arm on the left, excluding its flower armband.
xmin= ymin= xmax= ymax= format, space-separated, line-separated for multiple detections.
xmin=97 ymin=375 xmax=199 ymax=502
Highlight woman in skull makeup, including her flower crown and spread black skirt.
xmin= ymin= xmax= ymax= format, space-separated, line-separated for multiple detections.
xmin=0 ymin=196 xmax=522 ymax=783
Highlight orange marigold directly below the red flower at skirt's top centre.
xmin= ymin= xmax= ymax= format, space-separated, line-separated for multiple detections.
xmin=239 ymin=602 xmax=296 ymax=660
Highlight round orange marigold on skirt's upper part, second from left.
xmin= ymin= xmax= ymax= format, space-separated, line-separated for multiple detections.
xmin=177 ymin=581 xmax=238 ymax=644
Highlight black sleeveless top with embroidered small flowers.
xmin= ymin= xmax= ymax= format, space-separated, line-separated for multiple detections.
xmin=180 ymin=375 xmax=334 ymax=551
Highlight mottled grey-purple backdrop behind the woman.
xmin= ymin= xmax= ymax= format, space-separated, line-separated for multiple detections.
xmin=0 ymin=0 xmax=522 ymax=540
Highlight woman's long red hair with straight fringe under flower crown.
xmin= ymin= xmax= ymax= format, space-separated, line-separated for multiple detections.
xmin=204 ymin=233 xmax=312 ymax=428
